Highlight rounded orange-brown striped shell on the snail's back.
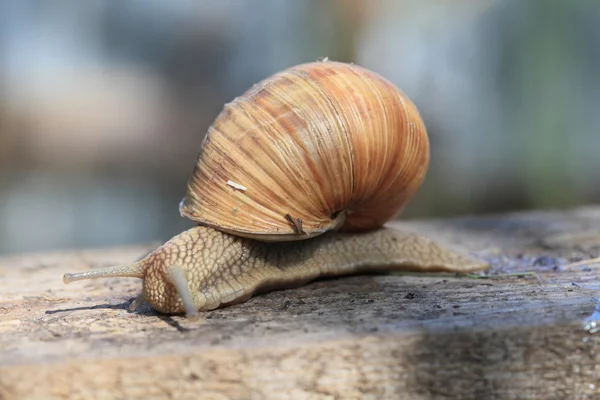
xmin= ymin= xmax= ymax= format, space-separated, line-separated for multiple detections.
xmin=180 ymin=61 xmax=429 ymax=241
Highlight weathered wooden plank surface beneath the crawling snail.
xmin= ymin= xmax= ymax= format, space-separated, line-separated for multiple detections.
xmin=0 ymin=207 xmax=600 ymax=400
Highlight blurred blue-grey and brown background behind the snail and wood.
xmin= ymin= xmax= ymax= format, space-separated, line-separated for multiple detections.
xmin=0 ymin=0 xmax=600 ymax=253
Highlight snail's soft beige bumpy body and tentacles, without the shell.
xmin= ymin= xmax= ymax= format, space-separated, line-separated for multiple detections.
xmin=64 ymin=226 xmax=489 ymax=316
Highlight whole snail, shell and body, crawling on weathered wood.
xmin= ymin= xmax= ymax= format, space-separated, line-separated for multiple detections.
xmin=63 ymin=61 xmax=489 ymax=317
